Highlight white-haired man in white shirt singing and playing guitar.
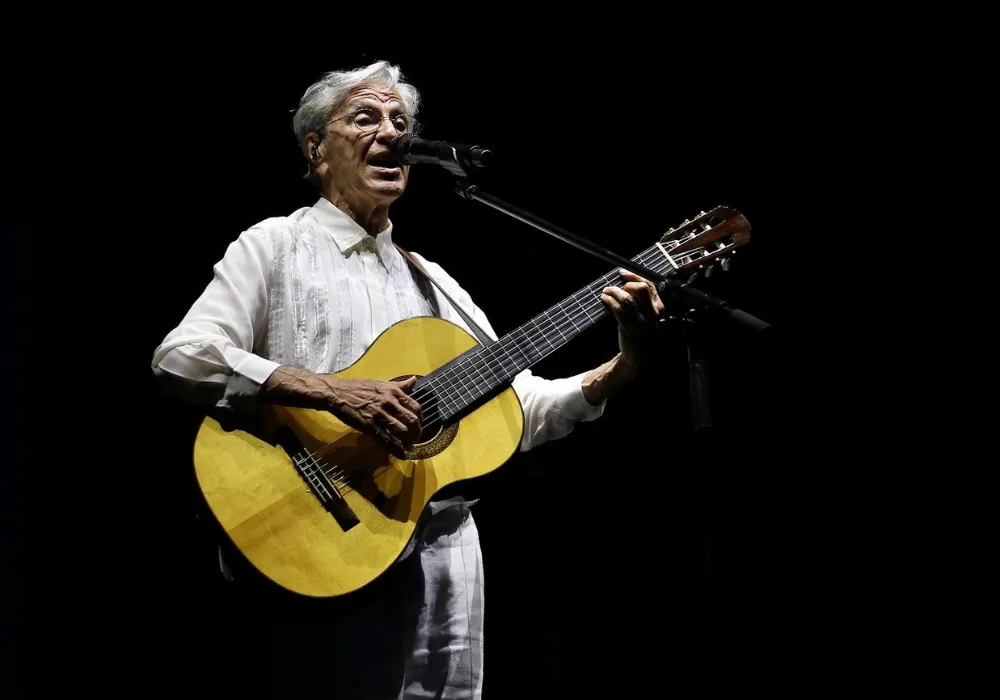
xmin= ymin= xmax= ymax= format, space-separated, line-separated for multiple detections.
xmin=153 ymin=62 xmax=663 ymax=699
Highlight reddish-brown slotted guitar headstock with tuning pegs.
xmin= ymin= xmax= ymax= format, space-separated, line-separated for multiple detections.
xmin=660 ymin=207 xmax=750 ymax=280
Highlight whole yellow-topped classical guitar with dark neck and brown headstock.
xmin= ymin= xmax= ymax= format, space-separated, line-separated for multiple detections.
xmin=194 ymin=207 xmax=750 ymax=598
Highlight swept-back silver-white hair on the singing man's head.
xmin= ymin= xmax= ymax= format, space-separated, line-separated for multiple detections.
xmin=292 ymin=61 xmax=420 ymax=185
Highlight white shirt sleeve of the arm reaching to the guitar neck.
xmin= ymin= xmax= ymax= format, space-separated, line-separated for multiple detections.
xmin=414 ymin=253 xmax=607 ymax=452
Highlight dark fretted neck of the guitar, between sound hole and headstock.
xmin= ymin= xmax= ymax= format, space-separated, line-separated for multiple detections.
xmin=418 ymin=245 xmax=673 ymax=418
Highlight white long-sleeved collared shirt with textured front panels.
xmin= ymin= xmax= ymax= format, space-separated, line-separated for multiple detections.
xmin=152 ymin=198 xmax=604 ymax=451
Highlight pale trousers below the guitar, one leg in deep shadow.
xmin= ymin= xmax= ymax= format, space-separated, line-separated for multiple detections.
xmin=267 ymin=504 xmax=484 ymax=700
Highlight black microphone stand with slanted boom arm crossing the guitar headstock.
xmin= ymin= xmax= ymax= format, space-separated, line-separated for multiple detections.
xmin=449 ymin=174 xmax=770 ymax=626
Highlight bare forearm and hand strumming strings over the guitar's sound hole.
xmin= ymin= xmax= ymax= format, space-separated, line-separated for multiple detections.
xmin=261 ymin=366 xmax=422 ymax=457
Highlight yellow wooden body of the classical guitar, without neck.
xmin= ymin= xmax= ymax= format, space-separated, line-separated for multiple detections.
xmin=194 ymin=317 xmax=524 ymax=597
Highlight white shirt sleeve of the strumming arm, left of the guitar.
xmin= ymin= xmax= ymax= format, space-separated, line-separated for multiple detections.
xmin=152 ymin=228 xmax=279 ymax=409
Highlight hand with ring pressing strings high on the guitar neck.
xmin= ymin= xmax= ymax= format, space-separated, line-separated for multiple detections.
xmin=601 ymin=270 xmax=663 ymax=374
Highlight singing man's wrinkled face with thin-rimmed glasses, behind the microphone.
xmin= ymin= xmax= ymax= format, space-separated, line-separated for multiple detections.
xmin=321 ymin=84 xmax=410 ymax=206
